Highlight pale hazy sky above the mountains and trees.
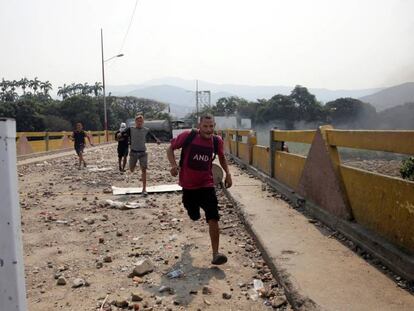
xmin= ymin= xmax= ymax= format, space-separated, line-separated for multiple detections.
xmin=0 ymin=0 xmax=414 ymax=89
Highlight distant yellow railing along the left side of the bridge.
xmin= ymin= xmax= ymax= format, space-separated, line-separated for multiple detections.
xmin=16 ymin=131 xmax=115 ymax=156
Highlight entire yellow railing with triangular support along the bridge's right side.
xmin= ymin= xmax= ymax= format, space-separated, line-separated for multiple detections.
xmin=222 ymin=126 xmax=414 ymax=252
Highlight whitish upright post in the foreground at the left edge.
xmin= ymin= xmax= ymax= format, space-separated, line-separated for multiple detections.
xmin=0 ymin=117 xmax=27 ymax=311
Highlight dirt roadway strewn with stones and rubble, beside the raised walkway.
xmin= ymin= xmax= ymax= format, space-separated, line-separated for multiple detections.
xmin=18 ymin=144 xmax=291 ymax=311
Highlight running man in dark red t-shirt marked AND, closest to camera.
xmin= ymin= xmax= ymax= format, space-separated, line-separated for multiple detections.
xmin=167 ymin=114 xmax=232 ymax=265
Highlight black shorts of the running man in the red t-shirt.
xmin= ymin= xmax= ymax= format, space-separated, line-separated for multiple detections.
xmin=183 ymin=188 xmax=220 ymax=222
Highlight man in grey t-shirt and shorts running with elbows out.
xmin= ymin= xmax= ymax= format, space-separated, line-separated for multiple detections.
xmin=118 ymin=115 xmax=161 ymax=196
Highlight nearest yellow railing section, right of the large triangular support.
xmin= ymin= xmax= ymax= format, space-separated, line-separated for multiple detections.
xmin=326 ymin=130 xmax=414 ymax=254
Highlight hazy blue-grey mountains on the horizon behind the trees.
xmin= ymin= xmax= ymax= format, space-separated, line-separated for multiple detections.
xmin=107 ymin=77 xmax=414 ymax=117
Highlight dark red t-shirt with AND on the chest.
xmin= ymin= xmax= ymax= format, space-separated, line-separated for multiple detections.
xmin=171 ymin=131 xmax=224 ymax=189
